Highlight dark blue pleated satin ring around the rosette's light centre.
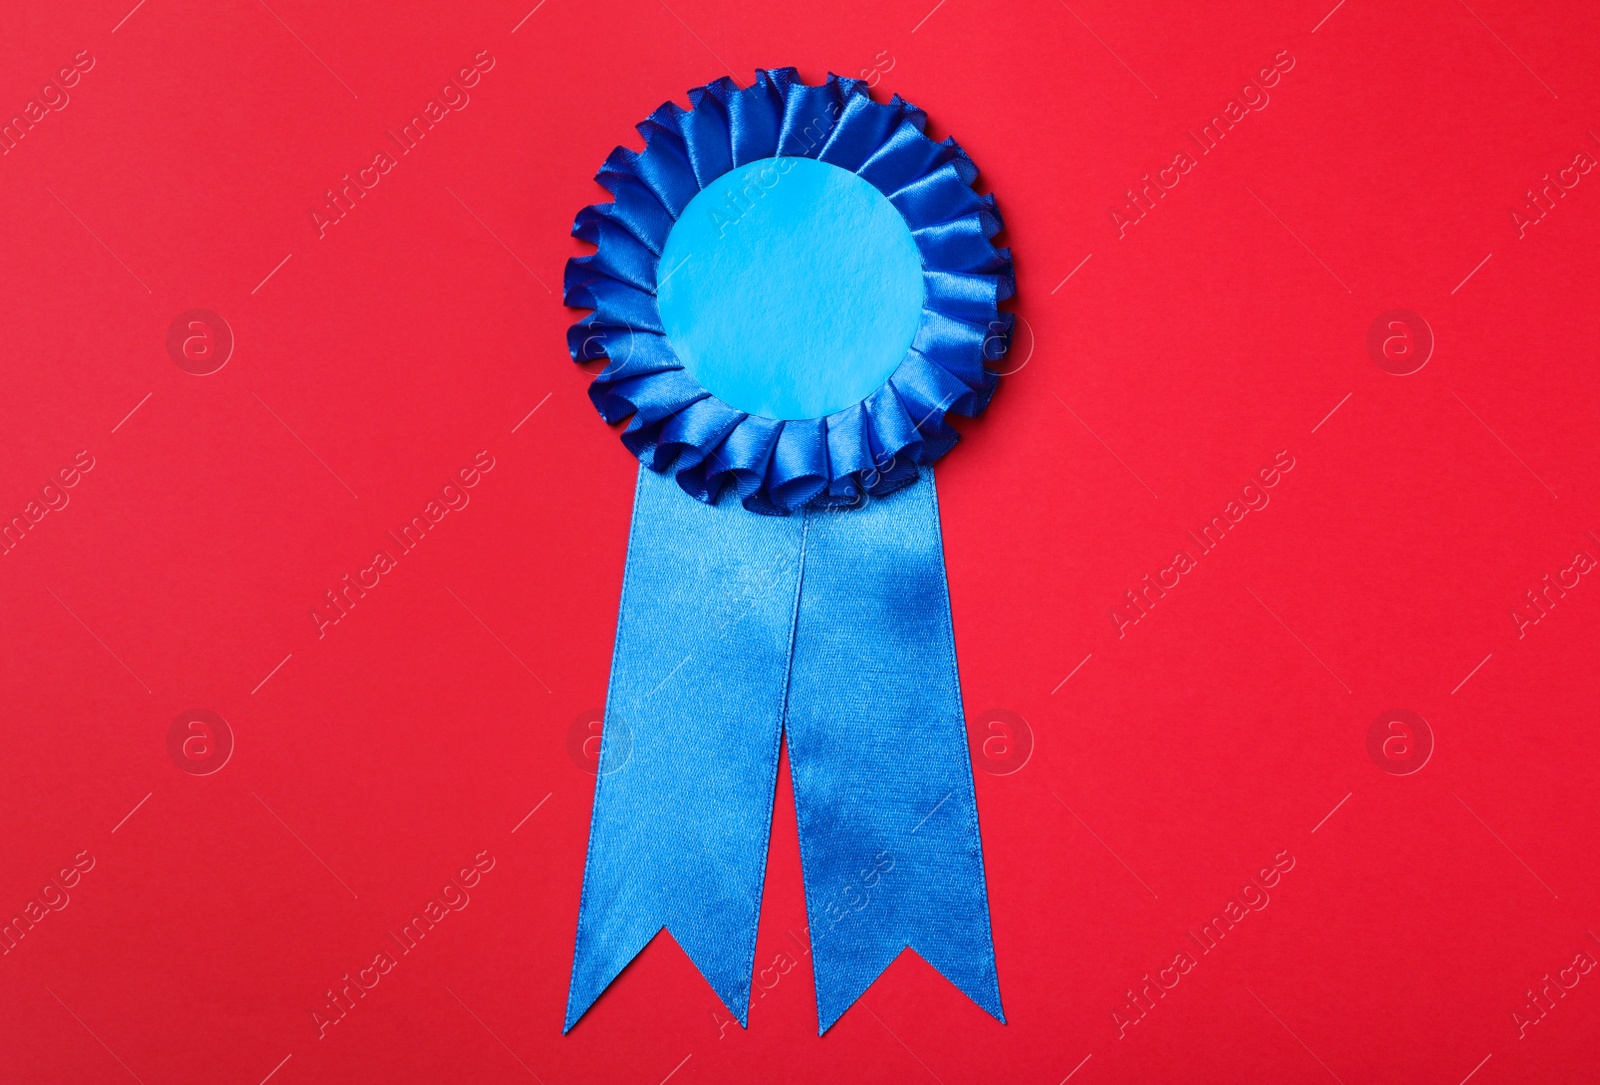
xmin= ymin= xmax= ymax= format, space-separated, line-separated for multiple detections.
xmin=563 ymin=67 xmax=1016 ymax=515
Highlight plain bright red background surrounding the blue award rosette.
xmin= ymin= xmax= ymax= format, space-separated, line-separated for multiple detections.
xmin=0 ymin=0 xmax=1600 ymax=1085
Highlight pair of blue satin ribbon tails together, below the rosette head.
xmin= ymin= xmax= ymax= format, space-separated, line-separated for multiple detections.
xmin=563 ymin=467 xmax=1005 ymax=1034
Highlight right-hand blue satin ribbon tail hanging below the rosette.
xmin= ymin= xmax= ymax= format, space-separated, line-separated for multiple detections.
xmin=786 ymin=467 xmax=1005 ymax=1034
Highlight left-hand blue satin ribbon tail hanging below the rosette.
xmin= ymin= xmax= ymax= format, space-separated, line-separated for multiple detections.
xmin=563 ymin=466 xmax=803 ymax=1031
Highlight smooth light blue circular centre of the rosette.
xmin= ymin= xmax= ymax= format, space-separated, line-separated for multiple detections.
xmin=656 ymin=157 xmax=923 ymax=419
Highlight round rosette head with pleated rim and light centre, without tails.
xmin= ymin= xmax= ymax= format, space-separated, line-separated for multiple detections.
xmin=562 ymin=69 xmax=1011 ymax=515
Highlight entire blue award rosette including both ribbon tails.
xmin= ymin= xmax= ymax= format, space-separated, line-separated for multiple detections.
xmin=565 ymin=69 xmax=1013 ymax=1034
